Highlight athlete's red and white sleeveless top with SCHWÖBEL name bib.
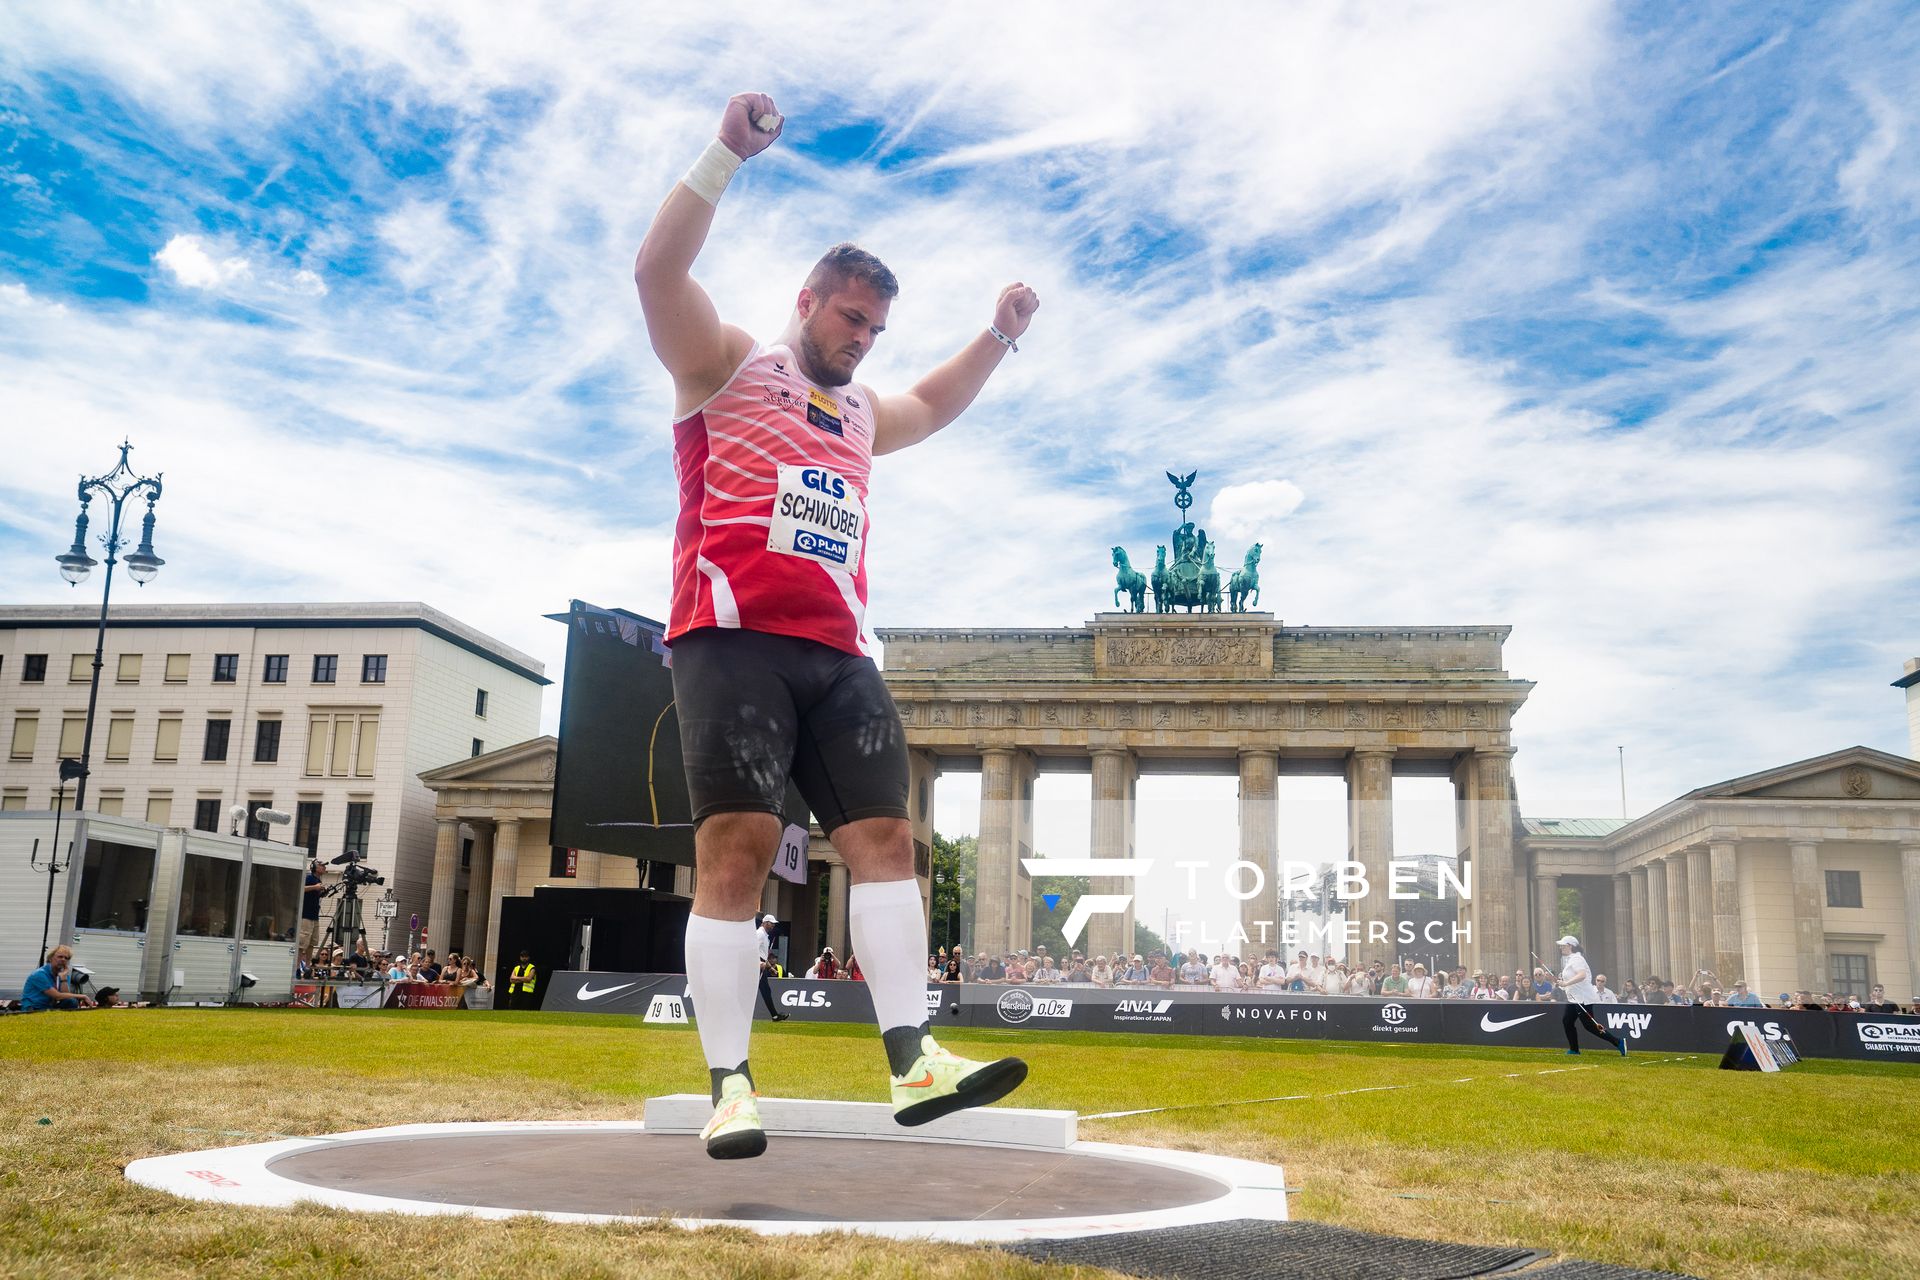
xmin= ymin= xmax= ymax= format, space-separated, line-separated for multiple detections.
xmin=666 ymin=344 xmax=874 ymax=654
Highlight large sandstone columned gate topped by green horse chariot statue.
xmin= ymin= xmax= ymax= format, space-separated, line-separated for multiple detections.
xmin=881 ymin=614 xmax=1532 ymax=973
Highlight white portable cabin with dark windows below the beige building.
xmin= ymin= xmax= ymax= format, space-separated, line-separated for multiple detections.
xmin=0 ymin=810 xmax=307 ymax=1004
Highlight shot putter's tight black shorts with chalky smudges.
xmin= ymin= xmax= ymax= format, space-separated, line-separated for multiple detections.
xmin=674 ymin=628 xmax=906 ymax=835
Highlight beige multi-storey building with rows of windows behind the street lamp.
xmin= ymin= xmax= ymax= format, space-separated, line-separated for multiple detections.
xmin=0 ymin=603 xmax=551 ymax=951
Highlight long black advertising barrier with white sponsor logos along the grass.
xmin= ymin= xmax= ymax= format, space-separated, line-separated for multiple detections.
xmin=541 ymin=973 xmax=1920 ymax=1065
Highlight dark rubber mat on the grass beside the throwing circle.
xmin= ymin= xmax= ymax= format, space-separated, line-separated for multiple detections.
xmin=1002 ymin=1219 xmax=1542 ymax=1280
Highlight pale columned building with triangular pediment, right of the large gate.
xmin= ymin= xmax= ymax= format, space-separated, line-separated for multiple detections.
xmin=1523 ymin=747 xmax=1920 ymax=1002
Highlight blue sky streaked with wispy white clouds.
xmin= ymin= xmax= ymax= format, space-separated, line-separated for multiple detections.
xmin=0 ymin=4 xmax=1920 ymax=924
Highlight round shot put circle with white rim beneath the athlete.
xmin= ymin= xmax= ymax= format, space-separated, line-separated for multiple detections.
xmin=127 ymin=1123 xmax=1286 ymax=1244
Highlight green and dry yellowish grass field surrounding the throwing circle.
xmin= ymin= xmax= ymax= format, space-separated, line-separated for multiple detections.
xmin=0 ymin=1009 xmax=1920 ymax=1280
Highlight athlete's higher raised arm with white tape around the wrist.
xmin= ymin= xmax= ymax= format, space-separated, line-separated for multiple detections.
xmin=634 ymin=94 xmax=781 ymax=413
